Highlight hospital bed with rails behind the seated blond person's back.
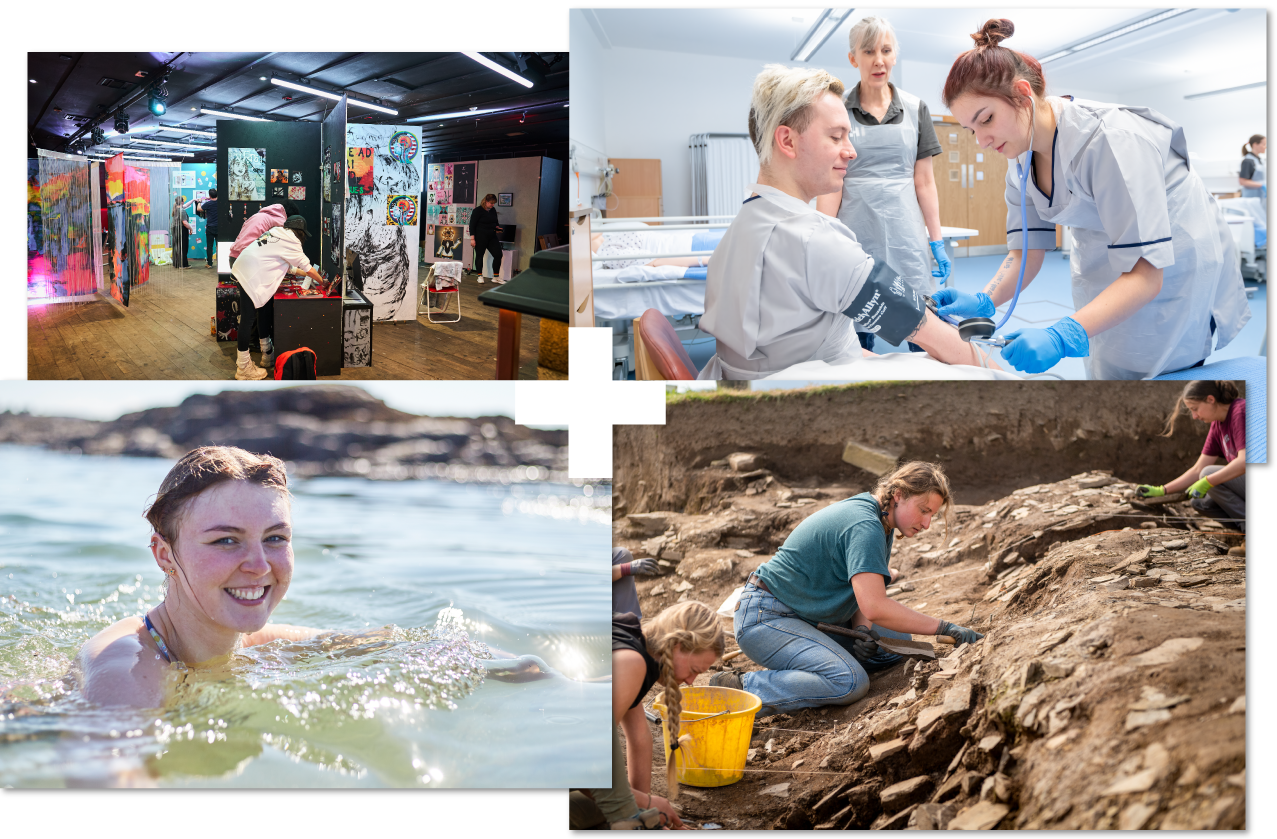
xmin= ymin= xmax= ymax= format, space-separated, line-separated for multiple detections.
xmin=593 ymin=216 xmax=979 ymax=379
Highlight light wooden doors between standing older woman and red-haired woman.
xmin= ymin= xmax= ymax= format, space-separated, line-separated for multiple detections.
xmin=931 ymin=123 xmax=1010 ymax=255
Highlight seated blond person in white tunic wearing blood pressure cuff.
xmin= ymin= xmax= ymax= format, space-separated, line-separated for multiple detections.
xmin=699 ymin=64 xmax=1000 ymax=379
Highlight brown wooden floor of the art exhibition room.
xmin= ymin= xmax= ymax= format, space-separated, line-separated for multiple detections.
xmin=27 ymin=261 xmax=566 ymax=381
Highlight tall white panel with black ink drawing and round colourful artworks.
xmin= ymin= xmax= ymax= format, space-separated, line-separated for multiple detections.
xmin=335 ymin=124 xmax=424 ymax=321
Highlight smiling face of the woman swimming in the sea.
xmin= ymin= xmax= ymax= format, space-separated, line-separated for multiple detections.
xmin=152 ymin=481 xmax=292 ymax=632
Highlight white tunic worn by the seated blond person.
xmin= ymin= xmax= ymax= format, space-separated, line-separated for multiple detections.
xmin=699 ymin=184 xmax=921 ymax=379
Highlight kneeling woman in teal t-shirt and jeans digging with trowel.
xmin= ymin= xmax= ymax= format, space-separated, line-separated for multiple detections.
xmin=710 ymin=461 xmax=983 ymax=716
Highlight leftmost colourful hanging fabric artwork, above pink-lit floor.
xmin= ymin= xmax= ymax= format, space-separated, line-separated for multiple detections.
xmin=27 ymin=157 xmax=97 ymax=301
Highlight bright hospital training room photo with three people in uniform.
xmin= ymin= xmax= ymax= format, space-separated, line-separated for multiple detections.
xmin=568 ymin=8 xmax=1268 ymax=389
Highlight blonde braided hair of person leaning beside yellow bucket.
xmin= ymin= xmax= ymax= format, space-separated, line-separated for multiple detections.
xmin=642 ymin=600 xmax=727 ymax=801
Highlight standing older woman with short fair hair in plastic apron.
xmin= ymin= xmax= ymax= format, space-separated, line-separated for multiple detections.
xmin=816 ymin=18 xmax=950 ymax=350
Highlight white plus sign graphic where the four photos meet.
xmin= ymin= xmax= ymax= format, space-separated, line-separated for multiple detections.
xmin=515 ymin=327 xmax=665 ymax=479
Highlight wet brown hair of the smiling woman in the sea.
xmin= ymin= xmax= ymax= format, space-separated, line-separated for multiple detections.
xmin=143 ymin=446 xmax=289 ymax=593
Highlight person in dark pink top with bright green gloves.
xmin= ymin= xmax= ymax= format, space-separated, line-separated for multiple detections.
xmin=1138 ymin=382 xmax=1246 ymax=533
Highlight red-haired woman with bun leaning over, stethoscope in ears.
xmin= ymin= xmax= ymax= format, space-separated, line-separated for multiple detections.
xmin=936 ymin=19 xmax=1250 ymax=379
